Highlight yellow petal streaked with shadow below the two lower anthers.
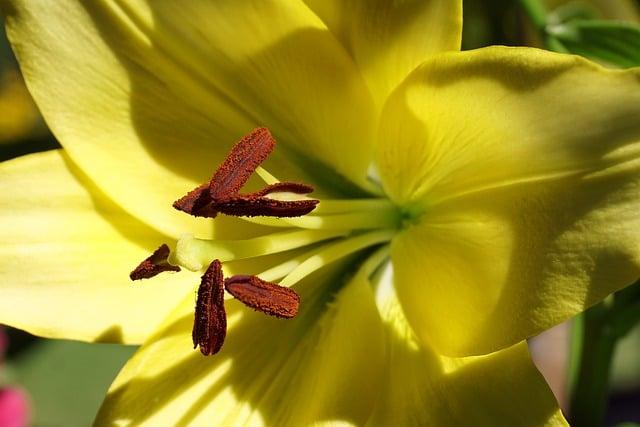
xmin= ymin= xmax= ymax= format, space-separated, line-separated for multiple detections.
xmin=96 ymin=260 xmax=383 ymax=426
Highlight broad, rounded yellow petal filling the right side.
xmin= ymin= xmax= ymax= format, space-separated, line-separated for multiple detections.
xmin=379 ymin=48 xmax=640 ymax=355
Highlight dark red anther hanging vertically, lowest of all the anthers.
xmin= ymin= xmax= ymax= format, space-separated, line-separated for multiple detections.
xmin=191 ymin=259 xmax=227 ymax=356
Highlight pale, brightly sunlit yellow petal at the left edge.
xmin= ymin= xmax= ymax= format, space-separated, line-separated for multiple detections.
xmin=0 ymin=151 xmax=193 ymax=344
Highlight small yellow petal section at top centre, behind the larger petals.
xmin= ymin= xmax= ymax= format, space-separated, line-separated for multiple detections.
xmin=305 ymin=0 xmax=462 ymax=110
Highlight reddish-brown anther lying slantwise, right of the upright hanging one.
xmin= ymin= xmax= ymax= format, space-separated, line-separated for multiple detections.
xmin=224 ymin=276 xmax=300 ymax=319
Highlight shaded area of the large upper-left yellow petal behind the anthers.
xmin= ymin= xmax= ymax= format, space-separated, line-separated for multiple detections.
xmin=83 ymin=2 xmax=375 ymax=200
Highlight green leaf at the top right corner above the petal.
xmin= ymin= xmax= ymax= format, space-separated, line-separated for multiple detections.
xmin=547 ymin=19 xmax=640 ymax=68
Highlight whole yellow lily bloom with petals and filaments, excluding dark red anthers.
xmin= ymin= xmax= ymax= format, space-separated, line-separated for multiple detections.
xmin=0 ymin=0 xmax=640 ymax=426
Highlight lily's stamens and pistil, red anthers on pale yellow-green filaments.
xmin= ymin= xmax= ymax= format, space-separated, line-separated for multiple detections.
xmin=130 ymin=128 xmax=406 ymax=355
